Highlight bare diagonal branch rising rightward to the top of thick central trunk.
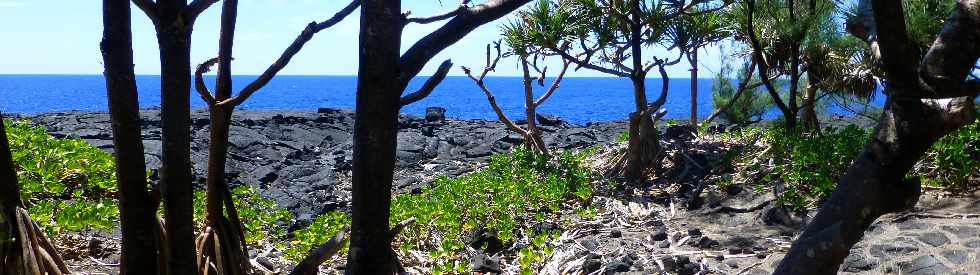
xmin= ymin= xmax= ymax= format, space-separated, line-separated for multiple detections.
xmin=218 ymin=0 xmax=361 ymax=107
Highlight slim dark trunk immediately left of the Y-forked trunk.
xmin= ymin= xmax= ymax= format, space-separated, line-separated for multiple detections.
xmin=101 ymin=0 xmax=158 ymax=274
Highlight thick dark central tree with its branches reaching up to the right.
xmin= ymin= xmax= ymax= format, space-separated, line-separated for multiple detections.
xmin=346 ymin=0 xmax=530 ymax=274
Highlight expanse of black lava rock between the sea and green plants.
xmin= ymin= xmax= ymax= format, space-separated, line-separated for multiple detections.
xmin=26 ymin=108 xmax=626 ymax=223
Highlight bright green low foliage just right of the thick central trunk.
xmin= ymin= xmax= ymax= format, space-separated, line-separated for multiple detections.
xmin=391 ymin=149 xmax=592 ymax=274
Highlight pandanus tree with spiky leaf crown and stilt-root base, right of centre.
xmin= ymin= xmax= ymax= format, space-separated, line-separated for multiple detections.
xmin=529 ymin=0 xmax=724 ymax=182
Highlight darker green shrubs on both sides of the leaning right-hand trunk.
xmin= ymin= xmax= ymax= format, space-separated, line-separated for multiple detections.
xmin=719 ymin=119 xmax=980 ymax=212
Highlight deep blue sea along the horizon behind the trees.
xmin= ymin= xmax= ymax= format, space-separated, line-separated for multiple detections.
xmin=0 ymin=75 xmax=884 ymax=123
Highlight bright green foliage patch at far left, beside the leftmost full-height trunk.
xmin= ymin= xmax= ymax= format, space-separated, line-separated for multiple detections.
xmin=4 ymin=121 xmax=119 ymax=235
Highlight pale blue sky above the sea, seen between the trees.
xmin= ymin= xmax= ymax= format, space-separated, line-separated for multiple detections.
xmin=0 ymin=0 xmax=719 ymax=78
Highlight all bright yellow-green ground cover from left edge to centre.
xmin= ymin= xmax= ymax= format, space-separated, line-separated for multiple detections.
xmin=6 ymin=121 xmax=594 ymax=274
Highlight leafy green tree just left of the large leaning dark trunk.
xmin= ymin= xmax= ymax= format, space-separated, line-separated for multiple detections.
xmin=732 ymin=0 xmax=876 ymax=131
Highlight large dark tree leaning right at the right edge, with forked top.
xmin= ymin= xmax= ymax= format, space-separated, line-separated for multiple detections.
xmin=775 ymin=0 xmax=980 ymax=274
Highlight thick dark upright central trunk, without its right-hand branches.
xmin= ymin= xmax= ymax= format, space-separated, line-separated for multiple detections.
xmin=346 ymin=0 xmax=405 ymax=274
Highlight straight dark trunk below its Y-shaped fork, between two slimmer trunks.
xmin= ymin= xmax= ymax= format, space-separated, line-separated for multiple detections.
xmin=157 ymin=17 xmax=196 ymax=274
